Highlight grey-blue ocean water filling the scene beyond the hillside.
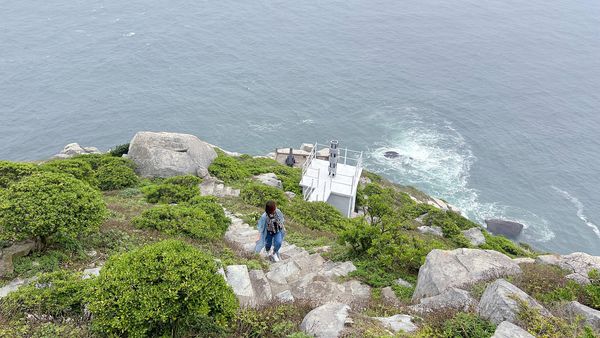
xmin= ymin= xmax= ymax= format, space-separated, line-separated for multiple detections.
xmin=0 ymin=0 xmax=600 ymax=255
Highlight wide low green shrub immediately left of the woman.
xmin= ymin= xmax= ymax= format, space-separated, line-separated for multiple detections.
xmin=133 ymin=204 xmax=227 ymax=239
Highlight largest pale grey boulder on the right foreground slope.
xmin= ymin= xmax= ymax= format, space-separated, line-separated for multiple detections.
xmin=413 ymin=248 xmax=521 ymax=301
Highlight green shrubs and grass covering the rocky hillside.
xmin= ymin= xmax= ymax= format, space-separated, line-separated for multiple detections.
xmin=0 ymin=149 xmax=600 ymax=338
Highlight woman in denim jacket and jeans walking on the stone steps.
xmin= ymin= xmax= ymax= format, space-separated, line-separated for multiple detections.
xmin=254 ymin=201 xmax=285 ymax=262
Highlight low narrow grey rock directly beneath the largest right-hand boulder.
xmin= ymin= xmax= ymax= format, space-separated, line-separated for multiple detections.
xmin=409 ymin=288 xmax=477 ymax=315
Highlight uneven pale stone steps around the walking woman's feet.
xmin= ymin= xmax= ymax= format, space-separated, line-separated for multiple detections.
xmin=223 ymin=211 xmax=371 ymax=307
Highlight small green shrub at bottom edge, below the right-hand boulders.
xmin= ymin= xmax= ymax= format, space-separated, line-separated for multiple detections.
xmin=443 ymin=312 xmax=496 ymax=338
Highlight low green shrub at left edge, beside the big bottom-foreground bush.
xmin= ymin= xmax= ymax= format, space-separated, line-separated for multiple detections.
xmin=0 ymin=270 xmax=87 ymax=318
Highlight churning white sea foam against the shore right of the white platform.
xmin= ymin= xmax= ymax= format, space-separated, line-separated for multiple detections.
xmin=367 ymin=107 xmax=555 ymax=242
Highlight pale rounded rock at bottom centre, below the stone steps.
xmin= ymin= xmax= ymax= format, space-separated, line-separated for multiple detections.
xmin=300 ymin=302 xmax=350 ymax=338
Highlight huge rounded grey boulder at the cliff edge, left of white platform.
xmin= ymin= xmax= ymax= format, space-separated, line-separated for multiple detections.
xmin=128 ymin=131 xmax=217 ymax=177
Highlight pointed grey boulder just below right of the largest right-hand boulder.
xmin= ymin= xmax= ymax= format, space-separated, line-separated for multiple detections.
xmin=477 ymin=279 xmax=551 ymax=324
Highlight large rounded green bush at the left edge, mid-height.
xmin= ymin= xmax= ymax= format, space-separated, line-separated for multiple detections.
xmin=0 ymin=172 xmax=107 ymax=244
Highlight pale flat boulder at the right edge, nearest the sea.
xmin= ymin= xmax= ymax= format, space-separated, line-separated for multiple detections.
xmin=535 ymin=252 xmax=600 ymax=284
